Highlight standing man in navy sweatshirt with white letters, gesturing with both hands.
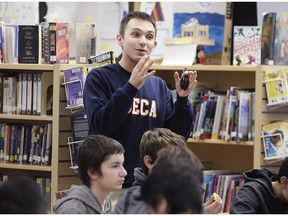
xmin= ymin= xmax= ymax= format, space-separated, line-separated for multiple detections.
xmin=84 ymin=12 xmax=197 ymax=187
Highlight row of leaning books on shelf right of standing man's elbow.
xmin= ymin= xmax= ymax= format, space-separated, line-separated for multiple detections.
xmin=191 ymin=87 xmax=255 ymax=141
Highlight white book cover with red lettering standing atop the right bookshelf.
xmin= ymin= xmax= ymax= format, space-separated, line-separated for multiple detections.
xmin=233 ymin=26 xmax=262 ymax=65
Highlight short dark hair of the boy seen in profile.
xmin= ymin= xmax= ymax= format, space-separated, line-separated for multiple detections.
xmin=77 ymin=135 xmax=125 ymax=187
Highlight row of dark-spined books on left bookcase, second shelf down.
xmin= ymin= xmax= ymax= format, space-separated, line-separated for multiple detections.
xmin=0 ymin=123 xmax=52 ymax=165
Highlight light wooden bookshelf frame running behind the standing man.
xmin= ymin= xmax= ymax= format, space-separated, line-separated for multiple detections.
xmin=0 ymin=64 xmax=280 ymax=212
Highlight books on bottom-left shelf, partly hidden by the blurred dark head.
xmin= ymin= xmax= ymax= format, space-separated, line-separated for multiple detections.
xmin=0 ymin=176 xmax=51 ymax=213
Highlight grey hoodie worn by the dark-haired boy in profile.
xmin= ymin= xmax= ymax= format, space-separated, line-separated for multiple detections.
xmin=53 ymin=185 xmax=111 ymax=214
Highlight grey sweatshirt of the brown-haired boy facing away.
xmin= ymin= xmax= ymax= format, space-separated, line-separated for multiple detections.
xmin=114 ymin=167 xmax=147 ymax=214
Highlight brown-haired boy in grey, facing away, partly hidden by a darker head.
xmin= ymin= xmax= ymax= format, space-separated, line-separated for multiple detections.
xmin=114 ymin=128 xmax=223 ymax=214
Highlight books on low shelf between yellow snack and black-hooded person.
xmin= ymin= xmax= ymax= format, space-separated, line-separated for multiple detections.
xmin=203 ymin=170 xmax=244 ymax=212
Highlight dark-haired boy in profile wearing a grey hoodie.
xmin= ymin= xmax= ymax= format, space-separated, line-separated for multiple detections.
xmin=53 ymin=135 xmax=127 ymax=214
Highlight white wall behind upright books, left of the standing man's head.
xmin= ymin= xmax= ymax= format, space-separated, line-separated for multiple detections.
xmin=45 ymin=2 xmax=128 ymax=57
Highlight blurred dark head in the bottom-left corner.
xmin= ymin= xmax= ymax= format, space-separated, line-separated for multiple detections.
xmin=0 ymin=176 xmax=46 ymax=214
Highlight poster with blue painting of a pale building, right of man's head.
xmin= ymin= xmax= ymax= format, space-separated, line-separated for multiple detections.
xmin=162 ymin=2 xmax=232 ymax=64
